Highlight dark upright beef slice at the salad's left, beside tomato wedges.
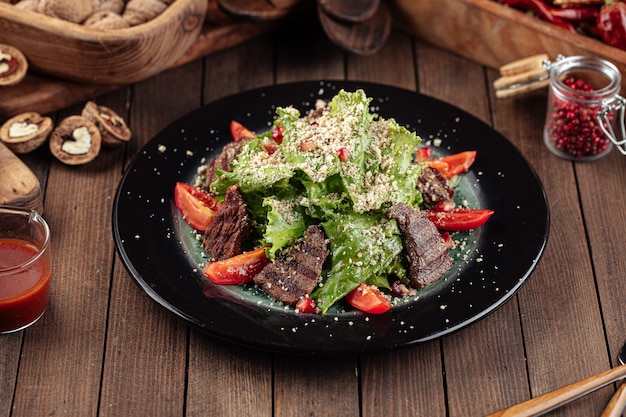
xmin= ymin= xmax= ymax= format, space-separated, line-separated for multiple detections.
xmin=202 ymin=185 xmax=252 ymax=261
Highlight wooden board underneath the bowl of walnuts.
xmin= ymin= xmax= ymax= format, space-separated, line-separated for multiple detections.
xmin=0 ymin=22 xmax=279 ymax=122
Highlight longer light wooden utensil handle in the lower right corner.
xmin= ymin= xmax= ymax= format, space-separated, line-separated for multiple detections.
xmin=487 ymin=365 xmax=626 ymax=417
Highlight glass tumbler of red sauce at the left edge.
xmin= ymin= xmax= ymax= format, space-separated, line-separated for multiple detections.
xmin=0 ymin=206 xmax=52 ymax=334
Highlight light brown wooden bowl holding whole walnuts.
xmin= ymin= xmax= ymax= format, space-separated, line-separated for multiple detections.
xmin=0 ymin=0 xmax=208 ymax=84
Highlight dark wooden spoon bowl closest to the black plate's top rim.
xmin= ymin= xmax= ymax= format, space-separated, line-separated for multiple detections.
xmin=317 ymin=3 xmax=392 ymax=55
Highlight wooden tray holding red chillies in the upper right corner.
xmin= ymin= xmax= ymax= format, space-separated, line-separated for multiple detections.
xmin=391 ymin=0 xmax=626 ymax=92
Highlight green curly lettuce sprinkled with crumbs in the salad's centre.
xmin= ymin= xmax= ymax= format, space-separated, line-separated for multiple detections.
xmin=211 ymin=90 xmax=422 ymax=312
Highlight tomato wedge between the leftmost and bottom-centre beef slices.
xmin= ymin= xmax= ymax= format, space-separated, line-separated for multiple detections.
xmin=203 ymin=247 xmax=268 ymax=285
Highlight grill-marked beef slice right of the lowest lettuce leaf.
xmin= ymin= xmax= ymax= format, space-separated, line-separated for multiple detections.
xmin=389 ymin=203 xmax=452 ymax=288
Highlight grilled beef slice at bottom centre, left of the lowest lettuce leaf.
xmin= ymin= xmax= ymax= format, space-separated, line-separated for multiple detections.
xmin=254 ymin=225 xmax=328 ymax=305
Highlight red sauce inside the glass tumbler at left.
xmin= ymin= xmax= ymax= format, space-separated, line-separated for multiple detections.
xmin=0 ymin=239 xmax=52 ymax=332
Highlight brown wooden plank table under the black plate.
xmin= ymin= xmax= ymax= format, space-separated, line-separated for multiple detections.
xmin=0 ymin=17 xmax=626 ymax=417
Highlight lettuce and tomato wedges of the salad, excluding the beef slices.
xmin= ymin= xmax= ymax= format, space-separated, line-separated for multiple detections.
xmin=175 ymin=90 xmax=493 ymax=314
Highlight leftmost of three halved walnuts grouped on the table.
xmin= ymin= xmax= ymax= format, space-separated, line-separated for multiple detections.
xmin=0 ymin=112 xmax=52 ymax=153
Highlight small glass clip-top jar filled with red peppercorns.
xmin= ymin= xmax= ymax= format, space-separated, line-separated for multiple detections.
xmin=543 ymin=56 xmax=626 ymax=161
